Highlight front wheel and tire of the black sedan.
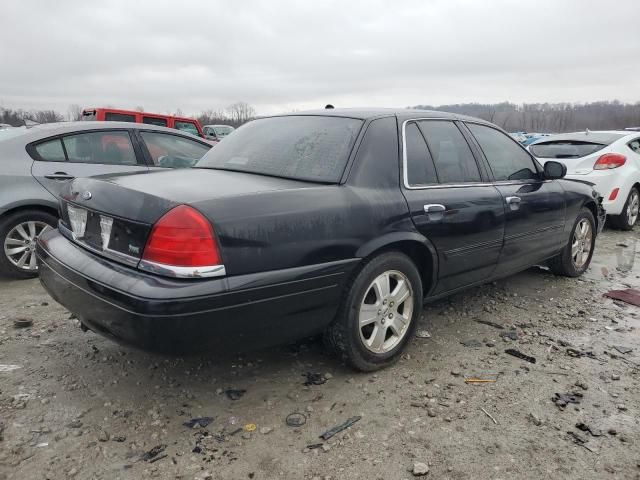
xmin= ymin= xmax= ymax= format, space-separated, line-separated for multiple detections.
xmin=547 ymin=208 xmax=597 ymax=277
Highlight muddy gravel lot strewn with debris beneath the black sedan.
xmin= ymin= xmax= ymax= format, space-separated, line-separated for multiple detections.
xmin=0 ymin=230 xmax=640 ymax=480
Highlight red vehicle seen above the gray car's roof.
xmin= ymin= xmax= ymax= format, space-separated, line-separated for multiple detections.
xmin=82 ymin=108 xmax=205 ymax=138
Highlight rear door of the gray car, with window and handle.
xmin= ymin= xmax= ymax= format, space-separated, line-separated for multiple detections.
xmin=27 ymin=129 xmax=149 ymax=196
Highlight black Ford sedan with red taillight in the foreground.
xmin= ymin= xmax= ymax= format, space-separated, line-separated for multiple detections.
xmin=37 ymin=110 xmax=604 ymax=370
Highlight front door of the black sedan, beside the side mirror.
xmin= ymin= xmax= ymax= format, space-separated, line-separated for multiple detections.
xmin=465 ymin=122 xmax=567 ymax=274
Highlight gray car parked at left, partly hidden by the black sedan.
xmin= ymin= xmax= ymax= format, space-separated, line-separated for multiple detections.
xmin=0 ymin=122 xmax=211 ymax=278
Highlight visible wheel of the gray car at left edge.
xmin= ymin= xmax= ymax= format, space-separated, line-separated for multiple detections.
xmin=0 ymin=209 xmax=58 ymax=279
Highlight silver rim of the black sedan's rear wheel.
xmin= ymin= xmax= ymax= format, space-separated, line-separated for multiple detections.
xmin=358 ymin=270 xmax=414 ymax=354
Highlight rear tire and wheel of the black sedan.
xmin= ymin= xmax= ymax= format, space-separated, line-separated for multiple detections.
xmin=325 ymin=252 xmax=422 ymax=372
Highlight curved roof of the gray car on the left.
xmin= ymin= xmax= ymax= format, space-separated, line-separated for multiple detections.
xmin=0 ymin=121 xmax=202 ymax=144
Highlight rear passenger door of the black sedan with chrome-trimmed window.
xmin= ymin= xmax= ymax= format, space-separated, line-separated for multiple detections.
xmin=402 ymin=119 xmax=504 ymax=294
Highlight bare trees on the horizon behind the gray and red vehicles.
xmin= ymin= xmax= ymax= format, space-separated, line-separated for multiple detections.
xmin=0 ymin=102 xmax=256 ymax=127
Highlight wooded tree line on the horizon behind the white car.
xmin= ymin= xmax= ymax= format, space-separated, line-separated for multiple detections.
xmin=411 ymin=100 xmax=640 ymax=133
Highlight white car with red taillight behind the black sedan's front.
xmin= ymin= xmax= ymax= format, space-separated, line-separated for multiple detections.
xmin=529 ymin=130 xmax=640 ymax=230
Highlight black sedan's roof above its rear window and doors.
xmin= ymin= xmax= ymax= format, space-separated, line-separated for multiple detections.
xmin=273 ymin=108 xmax=490 ymax=124
